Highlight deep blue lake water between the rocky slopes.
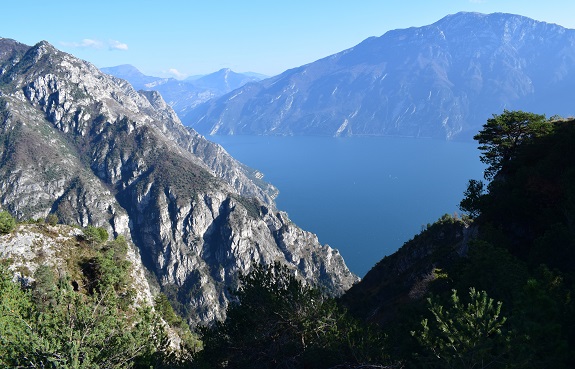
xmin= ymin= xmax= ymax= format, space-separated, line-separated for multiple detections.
xmin=207 ymin=136 xmax=485 ymax=276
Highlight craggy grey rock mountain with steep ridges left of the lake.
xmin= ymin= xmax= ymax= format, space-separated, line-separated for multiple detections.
xmin=0 ymin=39 xmax=357 ymax=323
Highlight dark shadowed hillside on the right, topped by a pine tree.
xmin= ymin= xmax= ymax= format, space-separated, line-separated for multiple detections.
xmin=341 ymin=115 xmax=575 ymax=368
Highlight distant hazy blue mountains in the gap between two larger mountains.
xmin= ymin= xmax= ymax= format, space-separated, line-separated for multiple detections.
xmin=101 ymin=65 xmax=266 ymax=117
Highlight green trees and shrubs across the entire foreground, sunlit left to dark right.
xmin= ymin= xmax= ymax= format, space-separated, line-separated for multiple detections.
xmin=0 ymin=111 xmax=575 ymax=368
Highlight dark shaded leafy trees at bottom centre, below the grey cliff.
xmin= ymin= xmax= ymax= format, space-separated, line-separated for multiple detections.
xmin=196 ymin=264 xmax=389 ymax=368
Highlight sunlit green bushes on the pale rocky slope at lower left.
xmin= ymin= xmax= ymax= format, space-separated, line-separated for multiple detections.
xmin=0 ymin=223 xmax=197 ymax=368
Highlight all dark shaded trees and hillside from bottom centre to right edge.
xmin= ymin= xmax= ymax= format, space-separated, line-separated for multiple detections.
xmin=196 ymin=111 xmax=575 ymax=368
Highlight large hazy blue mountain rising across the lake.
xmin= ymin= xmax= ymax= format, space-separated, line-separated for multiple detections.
xmin=182 ymin=13 xmax=575 ymax=139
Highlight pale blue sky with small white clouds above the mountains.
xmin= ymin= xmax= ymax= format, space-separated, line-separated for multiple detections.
xmin=0 ymin=0 xmax=575 ymax=78
